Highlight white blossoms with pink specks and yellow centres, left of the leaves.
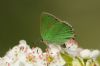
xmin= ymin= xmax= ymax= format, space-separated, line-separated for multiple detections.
xmin=0 ymin=40 xmax=65 ymax=66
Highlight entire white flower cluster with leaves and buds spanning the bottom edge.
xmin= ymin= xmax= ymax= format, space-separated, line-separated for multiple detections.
xmin=0 ymin=40 xmax=100 ymax=66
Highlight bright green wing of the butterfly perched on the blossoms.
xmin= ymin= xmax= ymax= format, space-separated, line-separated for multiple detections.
xmin=40 ymin=13 xmax=74 ymax=44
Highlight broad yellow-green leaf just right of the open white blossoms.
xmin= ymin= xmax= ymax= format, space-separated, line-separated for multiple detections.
xmin=61 ymin=53 xmax=73 ymax=66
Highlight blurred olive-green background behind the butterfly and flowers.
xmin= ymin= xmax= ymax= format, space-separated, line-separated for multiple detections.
xmin=0 ymin=0 xmax=100 ymax=56
